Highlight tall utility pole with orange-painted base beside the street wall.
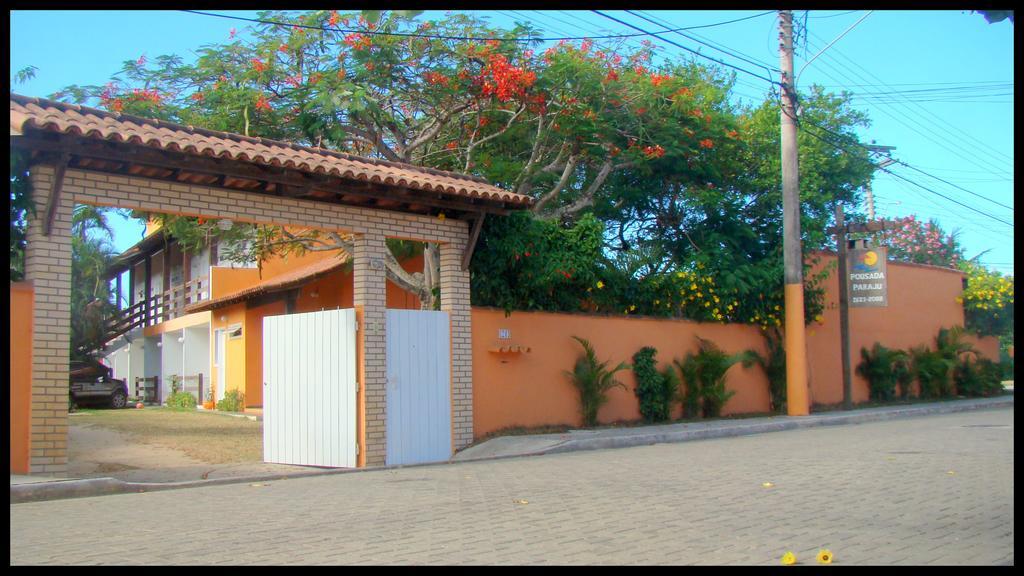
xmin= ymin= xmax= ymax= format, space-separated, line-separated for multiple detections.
xmin=778 ymin=10 xmax=810 ymax=416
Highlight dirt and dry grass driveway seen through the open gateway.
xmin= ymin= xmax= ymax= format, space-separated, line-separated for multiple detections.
xmin=68 ymin=408 xmax=317 ymax=483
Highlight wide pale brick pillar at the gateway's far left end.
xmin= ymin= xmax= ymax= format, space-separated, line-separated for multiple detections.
xmin=25 ymin=165 xmax=74 ymax=475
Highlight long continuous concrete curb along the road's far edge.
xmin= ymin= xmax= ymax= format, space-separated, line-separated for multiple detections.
xmin=10 ymin=395 xmax=1014 ymax=504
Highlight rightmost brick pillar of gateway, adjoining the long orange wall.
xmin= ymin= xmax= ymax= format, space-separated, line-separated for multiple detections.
xmin=440 ymin=240 xmax=473 ymax=450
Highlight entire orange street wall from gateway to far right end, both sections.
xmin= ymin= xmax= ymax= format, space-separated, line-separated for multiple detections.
xmin=472 ymin=254 xmax=998 ymax=438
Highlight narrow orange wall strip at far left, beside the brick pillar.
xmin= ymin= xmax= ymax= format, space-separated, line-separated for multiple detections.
xmin=8 ymin=282 xmax=35 ymax=474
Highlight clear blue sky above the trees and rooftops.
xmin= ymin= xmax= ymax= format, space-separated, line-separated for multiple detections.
xmin=10 ymin=10 xmax=1014 ymax=274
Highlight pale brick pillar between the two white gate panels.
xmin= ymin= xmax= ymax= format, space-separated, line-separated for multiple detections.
xmin=352 ymin=234 xmax=387 ymax=466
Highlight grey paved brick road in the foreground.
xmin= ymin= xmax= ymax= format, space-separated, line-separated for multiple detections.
xmin=10 ymin=409 xmax=1014 ymax=565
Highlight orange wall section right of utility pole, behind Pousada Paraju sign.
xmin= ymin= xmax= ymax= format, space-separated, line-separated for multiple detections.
xmin=807 ymin=253 xmax=999 ymax=405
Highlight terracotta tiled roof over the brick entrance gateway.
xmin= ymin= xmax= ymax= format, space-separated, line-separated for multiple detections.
xmin=10 ymin=93 xmax=532 ymax=208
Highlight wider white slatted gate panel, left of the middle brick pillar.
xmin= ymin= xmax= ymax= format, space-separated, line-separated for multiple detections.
xmin=263 ymin=308 xmax=356 ymax=467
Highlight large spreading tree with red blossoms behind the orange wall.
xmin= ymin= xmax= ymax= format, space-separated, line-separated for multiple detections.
xmin=48 ymin=10 xmax=871 ymax=327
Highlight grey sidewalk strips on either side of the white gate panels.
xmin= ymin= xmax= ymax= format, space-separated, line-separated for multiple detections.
xmin=10 ymin=394 xmax=1014 ymax=504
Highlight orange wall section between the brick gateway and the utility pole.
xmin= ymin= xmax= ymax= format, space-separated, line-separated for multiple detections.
xmin=472 ymin=307 xmax=768 ymax=438
